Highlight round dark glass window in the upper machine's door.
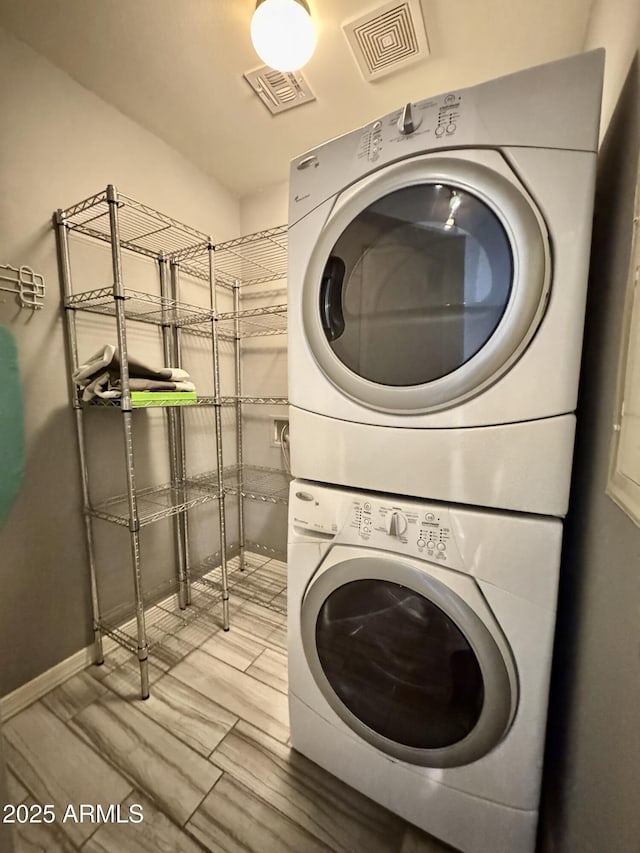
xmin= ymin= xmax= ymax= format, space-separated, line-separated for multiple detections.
xmin=320 ymin=184 xmax=513 ymax=386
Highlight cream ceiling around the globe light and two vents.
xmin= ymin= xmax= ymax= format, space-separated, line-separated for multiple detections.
xmin=0 ymin=0 xmax=593 ymax=196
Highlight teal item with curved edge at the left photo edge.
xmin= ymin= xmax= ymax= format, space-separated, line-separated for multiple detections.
xmin=0 ymin=326 xmax=24 ymax=525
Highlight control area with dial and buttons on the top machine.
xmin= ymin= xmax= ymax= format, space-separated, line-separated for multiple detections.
xmin=356 ymin=92 xmax=464 ymax=163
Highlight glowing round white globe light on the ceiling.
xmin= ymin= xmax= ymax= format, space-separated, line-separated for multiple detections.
xmin=251 ymin=0 xmax=316 ymax=71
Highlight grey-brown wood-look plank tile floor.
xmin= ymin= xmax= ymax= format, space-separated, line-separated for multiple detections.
xmin=4 ymin=554 xmax=451 ymax=853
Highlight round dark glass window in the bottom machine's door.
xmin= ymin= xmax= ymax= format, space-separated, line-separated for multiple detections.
xmin=316 ymin=580 xmax=484 ymax=749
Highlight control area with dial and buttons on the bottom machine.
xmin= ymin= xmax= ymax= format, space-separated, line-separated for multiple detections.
xmin=346 ymin=498 xmax=455 ymax=563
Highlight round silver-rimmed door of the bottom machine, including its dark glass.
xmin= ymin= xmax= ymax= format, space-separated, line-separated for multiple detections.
xmin=301 ymin=552 xmax=517 ymax=767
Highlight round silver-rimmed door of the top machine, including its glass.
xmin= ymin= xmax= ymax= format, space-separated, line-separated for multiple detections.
xmin=303 ymin=151 xmax=550 ymax=413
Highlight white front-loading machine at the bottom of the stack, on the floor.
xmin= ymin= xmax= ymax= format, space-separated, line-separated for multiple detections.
xmin=288 ymin=480 xmax=562 ymax=853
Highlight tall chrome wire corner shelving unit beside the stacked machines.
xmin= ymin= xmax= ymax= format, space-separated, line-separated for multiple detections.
xmin=55 ymin=185 xmax=289 ymax=698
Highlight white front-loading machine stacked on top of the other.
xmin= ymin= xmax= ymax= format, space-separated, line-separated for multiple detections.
xmin=289 ymin=50 xmax=604 ymax=516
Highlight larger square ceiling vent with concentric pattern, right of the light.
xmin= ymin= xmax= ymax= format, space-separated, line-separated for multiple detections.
xmin=342 ymin=0 xmax=429 ymax=80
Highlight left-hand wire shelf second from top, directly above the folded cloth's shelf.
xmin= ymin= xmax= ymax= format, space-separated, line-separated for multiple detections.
xmin=64 ymin=287 xmax=214 ymax=326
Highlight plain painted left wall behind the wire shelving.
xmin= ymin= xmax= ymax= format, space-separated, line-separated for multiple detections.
xmin=0 ymin=29 xmax=241 ymax=693
